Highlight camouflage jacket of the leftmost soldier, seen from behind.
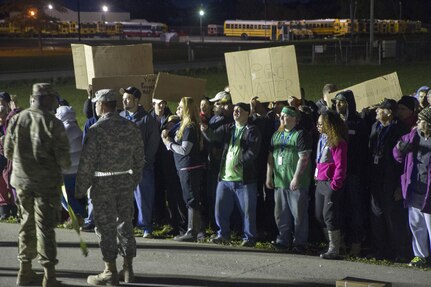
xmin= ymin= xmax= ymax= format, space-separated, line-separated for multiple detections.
xmin=4 ymin=106 xmax=70 ymax=189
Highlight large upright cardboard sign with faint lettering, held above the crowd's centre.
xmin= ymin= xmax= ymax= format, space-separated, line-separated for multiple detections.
xmin=225 ymin=46 xmax=301 ymax=103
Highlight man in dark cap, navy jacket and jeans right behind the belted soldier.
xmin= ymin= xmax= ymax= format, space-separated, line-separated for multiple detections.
xmin=120 ymin=87 xmax=159 ymax=238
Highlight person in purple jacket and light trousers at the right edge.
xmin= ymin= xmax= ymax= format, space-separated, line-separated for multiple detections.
xmin=393 ymin=108 xmax=431 ymax=267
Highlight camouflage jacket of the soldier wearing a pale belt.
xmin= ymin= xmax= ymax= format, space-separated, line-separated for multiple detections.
xmin=75 ymin=113 xmax=145 ymax=198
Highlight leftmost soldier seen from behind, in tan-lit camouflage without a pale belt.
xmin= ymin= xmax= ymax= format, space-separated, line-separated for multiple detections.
xmin=4 ymin=83 xmax=70 ymax=287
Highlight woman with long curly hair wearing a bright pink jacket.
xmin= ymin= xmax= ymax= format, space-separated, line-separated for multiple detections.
xmin=314 ymin=111 xmax=347 ymax=259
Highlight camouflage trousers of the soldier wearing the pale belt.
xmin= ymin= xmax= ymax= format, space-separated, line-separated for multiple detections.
xmin=90 ymin=175 xmax=136 ymax=262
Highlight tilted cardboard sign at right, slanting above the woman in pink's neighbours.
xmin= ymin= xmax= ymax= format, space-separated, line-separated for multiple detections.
xmin=328 ymin=72 xmax=403 ymax=111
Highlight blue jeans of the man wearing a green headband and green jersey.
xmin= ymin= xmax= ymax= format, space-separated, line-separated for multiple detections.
xmin=274 ymin=187 xmax=308 ymax=246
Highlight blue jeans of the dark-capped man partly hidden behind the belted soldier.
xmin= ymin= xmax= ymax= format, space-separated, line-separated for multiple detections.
xmin=135 ymin=165 xmax=155 ymax=232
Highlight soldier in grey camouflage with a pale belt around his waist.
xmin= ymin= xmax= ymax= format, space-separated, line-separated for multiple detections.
xmin=75 ymin=89 xmax=144 ymax=286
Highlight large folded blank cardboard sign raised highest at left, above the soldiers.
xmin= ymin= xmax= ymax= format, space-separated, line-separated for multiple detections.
xmin=71 ymin=44 xmax=154 ymax=90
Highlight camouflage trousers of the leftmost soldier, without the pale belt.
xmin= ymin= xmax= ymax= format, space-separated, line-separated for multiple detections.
xmin=16 ymin=188 xmax=61 ymax=267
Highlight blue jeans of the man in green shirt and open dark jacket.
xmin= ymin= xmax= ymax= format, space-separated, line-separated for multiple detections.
xmin=215 ymin=180 xmax=257 ymax=242
